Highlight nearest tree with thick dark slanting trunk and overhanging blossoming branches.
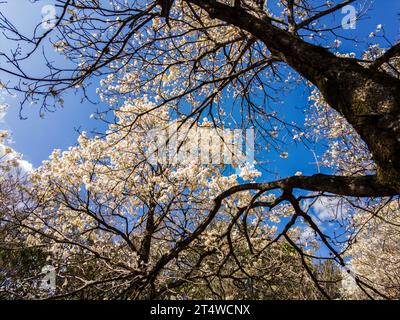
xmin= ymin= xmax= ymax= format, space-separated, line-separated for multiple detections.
xmin=0 ymin=0 xmax=400 ymax=298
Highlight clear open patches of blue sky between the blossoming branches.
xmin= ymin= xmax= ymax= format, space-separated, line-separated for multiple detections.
xmin=0 ymin=0 xmax=400 ymax=176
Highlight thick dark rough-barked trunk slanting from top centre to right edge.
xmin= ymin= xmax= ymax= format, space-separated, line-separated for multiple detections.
xmin=187 ymin=0 xmax=400 ymax=193
